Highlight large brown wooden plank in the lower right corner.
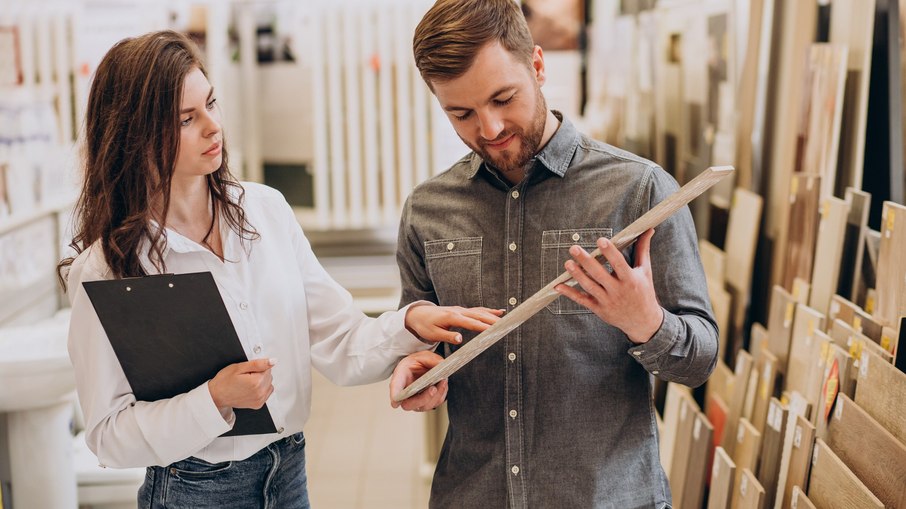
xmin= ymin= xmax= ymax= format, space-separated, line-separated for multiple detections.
xmin=827 ymin=394 xmax=906 ymax=508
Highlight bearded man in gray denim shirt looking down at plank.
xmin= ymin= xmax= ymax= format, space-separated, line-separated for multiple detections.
xmin=391 ymin=0 xmax=717 ymax=509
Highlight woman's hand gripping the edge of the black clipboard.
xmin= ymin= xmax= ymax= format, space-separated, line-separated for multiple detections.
xmin=208 ymin=359 xmax=276 ymax=411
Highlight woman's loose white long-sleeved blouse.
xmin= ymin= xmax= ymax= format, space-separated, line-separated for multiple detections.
xmin=68 ymin=183 xmax=431 ymax=467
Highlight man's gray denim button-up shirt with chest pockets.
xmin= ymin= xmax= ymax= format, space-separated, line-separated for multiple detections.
xmin=397 ymin=112 xmax=717 ymax=509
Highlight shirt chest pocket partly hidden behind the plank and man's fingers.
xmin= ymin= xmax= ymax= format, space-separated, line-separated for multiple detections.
xmin=541 ymin=228 xmax=613 ymax=315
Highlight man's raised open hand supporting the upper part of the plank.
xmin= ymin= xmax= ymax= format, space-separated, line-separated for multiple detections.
xmin=555 ymin=230 xmax=664 ymax=344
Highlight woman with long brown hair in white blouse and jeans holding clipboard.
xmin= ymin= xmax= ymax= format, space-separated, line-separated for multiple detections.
xmin=59 ymin=31 xmax=498 ymax=508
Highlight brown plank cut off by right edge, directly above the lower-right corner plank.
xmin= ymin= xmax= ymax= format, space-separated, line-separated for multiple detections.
xmin=854 ymin=351 xmax=906 ymax=444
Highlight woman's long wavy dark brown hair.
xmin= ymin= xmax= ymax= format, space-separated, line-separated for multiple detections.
xmin=57 ymin=30 xmax=258 ymax=289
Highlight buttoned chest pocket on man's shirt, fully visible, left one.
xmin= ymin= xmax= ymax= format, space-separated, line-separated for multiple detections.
xmin=425 ymin=237 xmax=484 ymax=307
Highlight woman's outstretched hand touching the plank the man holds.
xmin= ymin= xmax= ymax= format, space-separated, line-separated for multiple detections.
xmin=406 ymin=305 xmax=503 ymax=345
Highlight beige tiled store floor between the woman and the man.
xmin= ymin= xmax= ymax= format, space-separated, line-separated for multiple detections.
xmin=305 ymin=372 xmax=430 ymax=509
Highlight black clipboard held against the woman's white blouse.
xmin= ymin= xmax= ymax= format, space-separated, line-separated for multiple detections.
xmin=82 ymin=272 xmax=277 ymax=436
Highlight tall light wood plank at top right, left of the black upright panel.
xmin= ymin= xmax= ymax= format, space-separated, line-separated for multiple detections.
xmin=829 ymin=0 xmax=875 ymax=196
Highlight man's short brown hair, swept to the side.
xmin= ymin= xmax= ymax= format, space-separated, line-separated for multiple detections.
xmin=412 ymin=0 xmax=535 ymax=90
